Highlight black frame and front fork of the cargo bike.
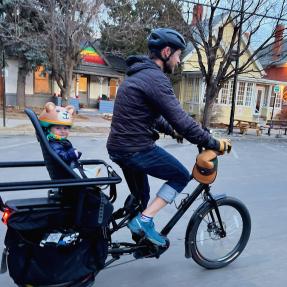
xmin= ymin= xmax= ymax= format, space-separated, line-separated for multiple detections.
xmin=105 ymin=180 xmax=225 ymax=267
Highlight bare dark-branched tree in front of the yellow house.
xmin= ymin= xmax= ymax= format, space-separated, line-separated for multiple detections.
xmin=183 ymin=0 xmax=286 ymax=126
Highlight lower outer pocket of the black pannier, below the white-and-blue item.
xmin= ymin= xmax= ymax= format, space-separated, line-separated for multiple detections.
xmin=6 ymin=229 xmax=96 ymax=285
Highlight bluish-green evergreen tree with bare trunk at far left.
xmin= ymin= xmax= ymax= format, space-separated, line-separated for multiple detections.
xmin=0 ymin=0 xmax=46 ymax=108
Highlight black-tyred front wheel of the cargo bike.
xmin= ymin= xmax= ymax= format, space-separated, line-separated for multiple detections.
xmin=186 ymin=197 xmax=251 ymax=269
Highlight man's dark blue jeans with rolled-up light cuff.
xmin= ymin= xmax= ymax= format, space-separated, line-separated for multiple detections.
xmin=110 ymin=146 xmax=190 ymax=208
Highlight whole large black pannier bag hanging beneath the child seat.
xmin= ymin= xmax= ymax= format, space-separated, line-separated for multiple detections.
xmin=5 ymin=191 xmax=113 ymax=285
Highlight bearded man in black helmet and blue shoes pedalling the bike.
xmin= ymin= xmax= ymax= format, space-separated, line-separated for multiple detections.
xmin=107 ymin=28 xmax=231 ymax=246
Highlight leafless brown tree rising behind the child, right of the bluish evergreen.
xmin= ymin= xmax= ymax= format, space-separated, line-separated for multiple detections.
xmin=29 ymin=0 xmax=102 ymax=100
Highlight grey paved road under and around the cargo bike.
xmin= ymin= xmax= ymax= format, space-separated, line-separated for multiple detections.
xmin=0 ymin=136 xmax=287 ymax=287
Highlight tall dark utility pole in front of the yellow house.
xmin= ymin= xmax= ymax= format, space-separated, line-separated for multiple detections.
xmin=228 ymin=0 xmax=244 ymax=135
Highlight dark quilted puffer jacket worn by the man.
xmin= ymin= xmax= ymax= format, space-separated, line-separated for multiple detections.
xmin=107 ymin=56 xmax=217 ymax=153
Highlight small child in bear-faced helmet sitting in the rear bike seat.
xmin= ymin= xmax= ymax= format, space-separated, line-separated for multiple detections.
xmin=39 ymin=102 xmax=100 ymax=177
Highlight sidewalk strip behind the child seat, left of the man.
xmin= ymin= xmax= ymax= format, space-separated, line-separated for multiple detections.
xmin=0 ymin=109 xmax=111 ymax=136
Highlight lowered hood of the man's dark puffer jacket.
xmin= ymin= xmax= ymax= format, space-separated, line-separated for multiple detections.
xmin=127 ymin=56 xmax=160 ymax=76
